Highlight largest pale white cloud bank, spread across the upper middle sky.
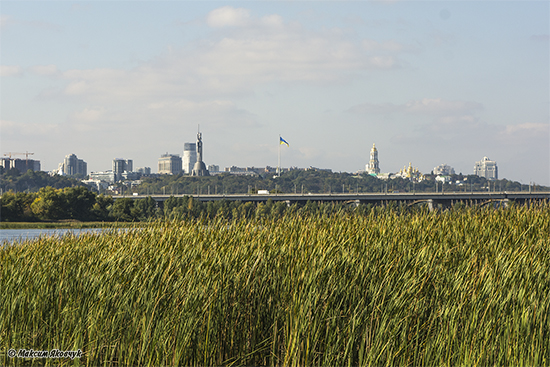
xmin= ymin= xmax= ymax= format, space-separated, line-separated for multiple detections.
xmin=50 ymin=7 xmax=414 ymax=108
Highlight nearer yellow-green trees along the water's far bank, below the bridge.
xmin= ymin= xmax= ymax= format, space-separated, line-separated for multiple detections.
xmin=0 ymin=186 xmax=422 ymax=222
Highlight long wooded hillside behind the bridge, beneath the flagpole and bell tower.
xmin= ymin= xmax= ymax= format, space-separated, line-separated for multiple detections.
xmin=133 ymin=170 xmax=550 ymax=195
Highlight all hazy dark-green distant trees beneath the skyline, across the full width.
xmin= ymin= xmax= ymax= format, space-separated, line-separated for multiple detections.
xmin=0 ymin=167 xmax=549 ymax=195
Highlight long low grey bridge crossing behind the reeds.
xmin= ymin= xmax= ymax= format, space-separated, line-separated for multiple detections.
xmin=118 ymin=191 xmax=550 ymax=209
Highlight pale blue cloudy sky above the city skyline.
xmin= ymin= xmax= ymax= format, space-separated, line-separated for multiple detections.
xmin=0 ymin=0 xmax=550 ymax=185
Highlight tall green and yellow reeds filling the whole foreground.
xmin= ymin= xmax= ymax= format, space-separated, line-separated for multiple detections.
xmin=0 ymin=205 xmax=550 ymax=366
